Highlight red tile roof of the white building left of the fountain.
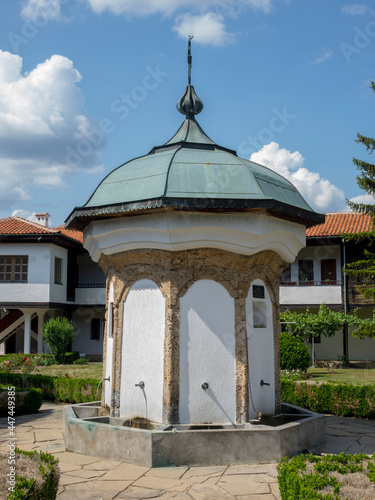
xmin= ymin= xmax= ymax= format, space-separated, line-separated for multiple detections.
xmin=0 ymin=217 xmax=83 ymax=244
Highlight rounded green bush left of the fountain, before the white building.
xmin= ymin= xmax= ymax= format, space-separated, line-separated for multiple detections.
xmin=43 ymin=316 xmax=76 ymax=362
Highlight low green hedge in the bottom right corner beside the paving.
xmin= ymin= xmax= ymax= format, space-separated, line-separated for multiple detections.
xmin=277 ymin=453 xmax=375 ymax=500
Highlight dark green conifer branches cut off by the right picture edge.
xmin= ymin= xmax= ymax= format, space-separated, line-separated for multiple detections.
xmin=344 ymin=82 xmax=375 ymax=299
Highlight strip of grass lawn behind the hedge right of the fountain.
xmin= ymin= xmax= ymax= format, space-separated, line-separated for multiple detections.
xmin=301 ymin=368 xmax=375 ymax=385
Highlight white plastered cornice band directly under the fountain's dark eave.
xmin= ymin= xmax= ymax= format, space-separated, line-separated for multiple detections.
xmin=83 ymin=212 xmax=306 ymax=262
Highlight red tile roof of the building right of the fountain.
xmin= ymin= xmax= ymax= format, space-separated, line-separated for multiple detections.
xmin=306 ymin=212 xmax=372 ymax=238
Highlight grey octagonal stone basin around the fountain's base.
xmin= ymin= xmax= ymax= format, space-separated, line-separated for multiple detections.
xmin=63 ymin=402 xmax=326 ymax=467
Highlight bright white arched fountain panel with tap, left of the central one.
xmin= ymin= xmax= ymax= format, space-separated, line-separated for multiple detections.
xmin=120 ymin=280 xmax=165 ymax=422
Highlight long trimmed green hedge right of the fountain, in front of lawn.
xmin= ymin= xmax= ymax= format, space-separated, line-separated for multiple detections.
xmin=281 ymin=380 xmax=375 ymax=419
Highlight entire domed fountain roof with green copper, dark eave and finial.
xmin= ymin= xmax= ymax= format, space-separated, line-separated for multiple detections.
xmin=66 ymin=43 xmax=323 ymax=229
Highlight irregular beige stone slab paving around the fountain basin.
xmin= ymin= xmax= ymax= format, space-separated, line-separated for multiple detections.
xmin=0 ymin=403 xmax=375 ymax=500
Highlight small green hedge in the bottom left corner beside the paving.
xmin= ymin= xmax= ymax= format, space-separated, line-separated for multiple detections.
xmin=6 ymin=448 xmax=60 ymax=500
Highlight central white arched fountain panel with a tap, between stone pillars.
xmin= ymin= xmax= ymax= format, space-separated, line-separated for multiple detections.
xmin=180 ymin=280 xmax=235 ymax=424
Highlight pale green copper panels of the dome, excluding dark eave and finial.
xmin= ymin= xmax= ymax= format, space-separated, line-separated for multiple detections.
xmin=84 ymin=119 xmax=311 ymax=211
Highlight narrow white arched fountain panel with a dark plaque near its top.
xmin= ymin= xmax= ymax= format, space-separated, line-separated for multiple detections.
xmin=246 ymin=279 xmax=275 ymax=418
